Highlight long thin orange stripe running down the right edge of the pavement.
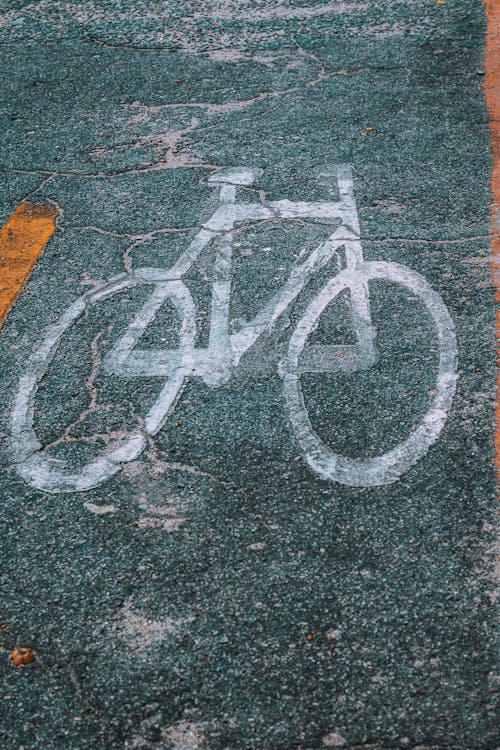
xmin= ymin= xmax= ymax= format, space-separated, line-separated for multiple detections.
xmin=484 ymin=0 xmax=500 ymax=473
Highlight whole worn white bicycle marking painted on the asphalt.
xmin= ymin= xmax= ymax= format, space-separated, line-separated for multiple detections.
xmin=11 ymin=171 xmax=457 ymax=500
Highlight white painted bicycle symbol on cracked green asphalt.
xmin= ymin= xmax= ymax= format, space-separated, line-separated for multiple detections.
xmin=11 ymin=166 xmax=457 ymax=493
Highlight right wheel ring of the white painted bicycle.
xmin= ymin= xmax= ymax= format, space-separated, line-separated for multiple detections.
xmin=281 ymin=262 xmax=457 ymax=487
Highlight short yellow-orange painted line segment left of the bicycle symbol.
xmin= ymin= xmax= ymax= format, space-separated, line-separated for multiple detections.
xmin=0 ymin=203 xmax=59 ymax=328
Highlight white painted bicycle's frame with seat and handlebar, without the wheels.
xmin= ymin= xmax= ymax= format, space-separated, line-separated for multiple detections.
xmin=103 ymin=167 xmax=375 ymax=434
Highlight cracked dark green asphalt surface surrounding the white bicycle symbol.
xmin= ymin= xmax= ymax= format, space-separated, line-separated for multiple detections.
xmin=0 ymin=0 xmax=500 ymax=750
